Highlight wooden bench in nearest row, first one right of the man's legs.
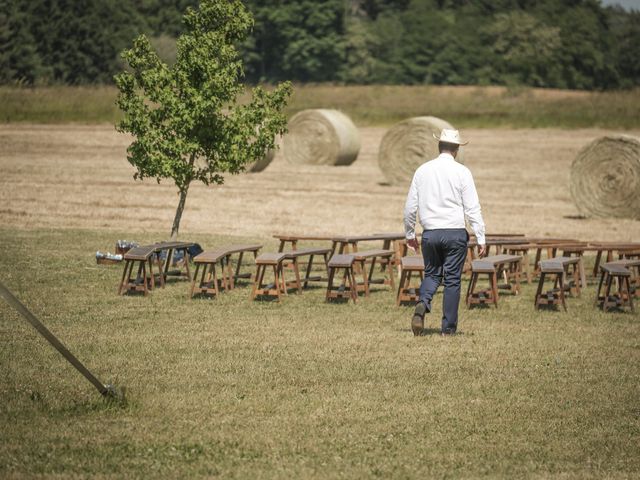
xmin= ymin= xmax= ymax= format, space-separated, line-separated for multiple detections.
xmin=466 ymin=254 xmax=522 ymax=308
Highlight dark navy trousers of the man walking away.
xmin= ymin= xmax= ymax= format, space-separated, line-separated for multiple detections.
xmin=420 ymin=228 xmax=469 ymax=332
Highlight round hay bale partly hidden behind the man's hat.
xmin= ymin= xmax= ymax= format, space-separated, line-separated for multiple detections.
xmin=378 ymin=117 xmax=463 ymax=185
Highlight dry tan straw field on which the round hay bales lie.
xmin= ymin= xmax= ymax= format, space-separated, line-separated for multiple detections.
xmin=0 ymin=125 xmax=640 ymax=241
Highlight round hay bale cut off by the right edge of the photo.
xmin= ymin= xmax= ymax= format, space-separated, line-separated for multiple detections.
xmin=570 ymin=135 xmax=640 ymax=219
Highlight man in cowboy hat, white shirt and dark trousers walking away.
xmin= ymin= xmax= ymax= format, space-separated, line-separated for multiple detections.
xmin=404 ymin=129 xmax=486 ymax=336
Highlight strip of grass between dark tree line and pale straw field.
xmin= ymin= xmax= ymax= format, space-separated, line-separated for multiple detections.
xmin=0 ymin=85 xmax=640 ymax=129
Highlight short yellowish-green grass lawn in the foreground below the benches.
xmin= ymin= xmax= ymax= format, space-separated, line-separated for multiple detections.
xmin=0 ymin=229 xmax=640 ymax=478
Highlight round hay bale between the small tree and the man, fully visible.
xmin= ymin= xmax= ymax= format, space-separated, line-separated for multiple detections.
xmin=284 ymin=109 xmax=360 ymax=165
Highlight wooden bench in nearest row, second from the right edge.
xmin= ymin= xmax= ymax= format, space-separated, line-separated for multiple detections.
xmin=534 ymin=257 xmax=582 ymax=312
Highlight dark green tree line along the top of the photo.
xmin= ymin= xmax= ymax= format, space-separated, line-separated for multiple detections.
xmin=0 ymin=0 xmax=640 ymax=89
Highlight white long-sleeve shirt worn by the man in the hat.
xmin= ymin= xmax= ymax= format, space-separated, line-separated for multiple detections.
xmin=404 ymin=153 xmax=485 ymax=245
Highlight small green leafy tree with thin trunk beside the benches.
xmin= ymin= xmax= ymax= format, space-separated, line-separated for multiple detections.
xmin=115 ymin=0 xmax=291 ymax=239
